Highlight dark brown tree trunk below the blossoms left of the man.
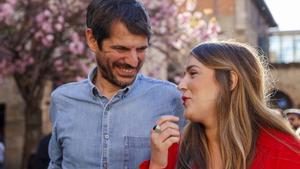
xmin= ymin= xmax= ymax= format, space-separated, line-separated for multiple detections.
xmin=15 ymin=75 xmax=45 ymax=169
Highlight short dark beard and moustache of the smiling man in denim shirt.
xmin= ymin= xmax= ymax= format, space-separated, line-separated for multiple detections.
xmin=96 ymin=58 xmax=143 ymax=88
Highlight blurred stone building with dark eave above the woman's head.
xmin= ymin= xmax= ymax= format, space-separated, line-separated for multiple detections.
xmin=198 ymin=0 xmax=277 ymax=48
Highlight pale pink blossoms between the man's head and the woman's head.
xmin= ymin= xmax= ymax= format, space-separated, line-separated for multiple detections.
xmin=143 ymin=0 xmax=220 ymax=82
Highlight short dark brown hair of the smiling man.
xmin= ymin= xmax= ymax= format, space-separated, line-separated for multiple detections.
xmin=86 ymin=0 xmax=152 ymax=48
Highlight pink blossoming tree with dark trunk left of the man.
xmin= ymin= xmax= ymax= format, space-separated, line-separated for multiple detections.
xmin=0 ymin=0 xmax=93 ymax=168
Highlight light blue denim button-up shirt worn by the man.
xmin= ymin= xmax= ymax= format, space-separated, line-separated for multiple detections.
xmin=48 ymin=69 xmax=184 ymax=169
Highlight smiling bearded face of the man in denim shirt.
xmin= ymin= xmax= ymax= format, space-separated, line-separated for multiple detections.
xmin=96 ymin=22 xmax=148 ymax=88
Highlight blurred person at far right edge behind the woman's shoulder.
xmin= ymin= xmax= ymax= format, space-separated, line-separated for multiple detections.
xmin=283 ymin=109 xmax=300 ymax=135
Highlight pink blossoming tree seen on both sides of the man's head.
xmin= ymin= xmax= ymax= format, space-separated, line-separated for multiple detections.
xmin=0 ymin=0 xmax=219 ymax=168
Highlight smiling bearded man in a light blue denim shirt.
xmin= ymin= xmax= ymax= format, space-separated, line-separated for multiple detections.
xmin=48 ymin=0 xmax=184 ymax=169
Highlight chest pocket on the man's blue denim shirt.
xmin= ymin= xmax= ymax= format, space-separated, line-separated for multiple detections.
xmin=124 ymin=136 xmax=150 ymax=169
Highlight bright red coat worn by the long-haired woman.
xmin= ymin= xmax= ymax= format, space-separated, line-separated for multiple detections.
xmin=140 ymin=130 xmax=300 ymax=169
